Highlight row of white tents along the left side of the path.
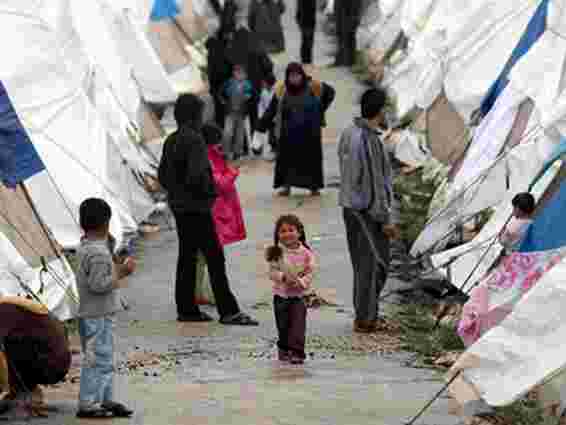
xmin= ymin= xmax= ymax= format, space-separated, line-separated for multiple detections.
xmin=0 ymin=0 xmax=211 ymax=320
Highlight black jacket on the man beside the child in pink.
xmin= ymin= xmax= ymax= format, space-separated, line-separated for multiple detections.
xmin=158 ymin=125 xmax=216 ymax=212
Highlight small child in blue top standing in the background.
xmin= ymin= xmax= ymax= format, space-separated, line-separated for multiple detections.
xmin=220 ymin=65 xmax=253 ymax=161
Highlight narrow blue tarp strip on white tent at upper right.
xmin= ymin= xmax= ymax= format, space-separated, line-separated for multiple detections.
xmin=480 ymin=0 xmax=550 ymax=117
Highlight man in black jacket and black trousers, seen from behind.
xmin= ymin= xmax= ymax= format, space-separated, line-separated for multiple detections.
xmin=158 ymin=94 xmax=258 ymax=326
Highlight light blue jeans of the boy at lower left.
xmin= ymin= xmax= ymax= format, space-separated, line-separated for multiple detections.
xmin=79 ymin=314 xmax=115 ymax=410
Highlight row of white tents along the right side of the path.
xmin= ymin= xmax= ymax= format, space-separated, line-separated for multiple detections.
xmin=358 ymin=0 xmax=566 ymax=418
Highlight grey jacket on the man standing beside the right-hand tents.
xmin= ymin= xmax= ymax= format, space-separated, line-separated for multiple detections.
xmin=338 ymin=118 xmax=393 ymax=224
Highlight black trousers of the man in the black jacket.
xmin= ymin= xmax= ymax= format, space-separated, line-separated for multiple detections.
xmin=173 ymin=211 xmax=240 ymax=317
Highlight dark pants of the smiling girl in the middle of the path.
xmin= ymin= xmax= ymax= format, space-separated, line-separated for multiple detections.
xmin=273 ymin=295 xmax=307 ymax=359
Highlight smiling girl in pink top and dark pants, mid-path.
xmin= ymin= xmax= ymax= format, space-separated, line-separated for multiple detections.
xmin=266 ymin=215 xmax=316 ymax=364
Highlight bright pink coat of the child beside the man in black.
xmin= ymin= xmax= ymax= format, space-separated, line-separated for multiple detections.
xmin=208 ymin=145 xmax=246 ymax=245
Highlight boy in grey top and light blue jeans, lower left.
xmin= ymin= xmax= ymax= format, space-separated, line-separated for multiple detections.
xmin=77 ymin=198 xmax=134 ymax=418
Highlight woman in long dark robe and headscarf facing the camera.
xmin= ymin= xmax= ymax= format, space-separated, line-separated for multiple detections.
xmin=258 ymin=63 xmax=335 ymax=196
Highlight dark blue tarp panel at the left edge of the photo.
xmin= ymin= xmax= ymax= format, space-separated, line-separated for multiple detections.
xmin=0 ymin=81 xmax=45 ymax=188
